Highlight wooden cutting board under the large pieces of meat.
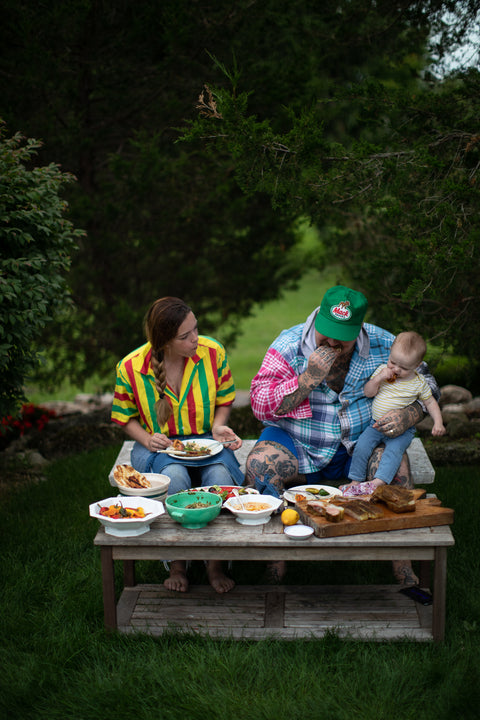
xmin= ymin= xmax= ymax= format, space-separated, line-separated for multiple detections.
xmin=295 ymin=490 xmax=454 ymax=537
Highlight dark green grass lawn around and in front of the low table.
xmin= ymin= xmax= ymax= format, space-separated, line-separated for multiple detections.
xmin=0 ymin=447 xmax=480 ymax=720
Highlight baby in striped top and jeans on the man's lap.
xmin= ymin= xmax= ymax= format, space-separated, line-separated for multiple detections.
xmin=340 ymin=332 xmax=446 ymax=495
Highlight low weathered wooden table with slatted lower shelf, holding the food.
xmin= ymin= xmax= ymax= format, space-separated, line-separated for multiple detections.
xmin=94 ymin=510 xmax=454 ymax=642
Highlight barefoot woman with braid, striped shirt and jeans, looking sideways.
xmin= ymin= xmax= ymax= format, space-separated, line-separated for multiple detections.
xmin=112 ymin=297 xmax=243 ymax=593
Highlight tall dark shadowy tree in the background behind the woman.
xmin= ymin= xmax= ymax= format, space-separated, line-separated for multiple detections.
xmin=0 ymin=0 xmax=476 ymax=382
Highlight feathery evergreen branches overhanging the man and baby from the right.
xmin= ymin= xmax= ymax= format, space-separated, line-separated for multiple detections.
xmin=186 ymin=70 xmax=480 ymax=376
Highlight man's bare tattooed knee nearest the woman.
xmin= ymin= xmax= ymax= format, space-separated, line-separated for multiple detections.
xmin=245 ymin=440 xmax=298 ymax=495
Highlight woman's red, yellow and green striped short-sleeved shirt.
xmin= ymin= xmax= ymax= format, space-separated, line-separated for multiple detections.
xmin=111 ymin=336 xmax=235 ymax=436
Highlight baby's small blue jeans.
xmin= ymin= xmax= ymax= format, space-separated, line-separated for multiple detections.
xmin=348 ymin=425 xmax=415 ymax=485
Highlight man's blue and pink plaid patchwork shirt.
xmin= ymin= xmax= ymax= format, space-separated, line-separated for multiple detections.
xmin=250 ymin=308 xmax=435 ymax=473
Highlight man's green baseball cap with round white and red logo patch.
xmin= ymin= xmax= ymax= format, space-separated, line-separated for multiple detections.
xmin=315 ymin=285 xmax=368 ymax=342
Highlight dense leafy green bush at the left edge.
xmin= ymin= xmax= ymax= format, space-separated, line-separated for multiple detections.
xmin=0 ymin=125 xmax=81 ymax=418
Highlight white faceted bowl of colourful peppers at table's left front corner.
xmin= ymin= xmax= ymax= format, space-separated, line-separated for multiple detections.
xmin=89 ymin=495 xmax=165 ymax=537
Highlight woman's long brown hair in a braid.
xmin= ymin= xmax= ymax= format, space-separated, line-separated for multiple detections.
xmin=145 ymin=297 xmax=192 ymax=427
